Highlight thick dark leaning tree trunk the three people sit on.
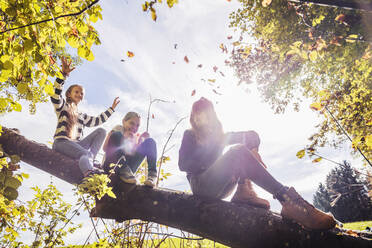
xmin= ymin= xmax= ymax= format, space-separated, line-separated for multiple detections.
xmin=0 ymin=127 xmax=372 ymax=248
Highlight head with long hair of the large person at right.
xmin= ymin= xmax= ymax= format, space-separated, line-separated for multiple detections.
xmin=190 ymin=97 xmax=224 ymax=144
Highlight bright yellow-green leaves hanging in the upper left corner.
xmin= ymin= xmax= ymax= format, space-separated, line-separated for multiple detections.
xmin=0 ymin=0 xmax=102 ymax=113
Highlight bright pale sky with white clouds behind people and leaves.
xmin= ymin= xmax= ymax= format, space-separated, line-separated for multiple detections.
xmin=1 ymin=0 xmax=360 ymax=244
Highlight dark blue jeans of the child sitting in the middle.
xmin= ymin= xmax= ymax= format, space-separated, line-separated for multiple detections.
xmin=103 ymin=131 xmax=157 ymax=174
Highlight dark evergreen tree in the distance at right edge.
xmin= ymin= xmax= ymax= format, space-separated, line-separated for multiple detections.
xmin=313 ymin=161 xmax=372 ymax=222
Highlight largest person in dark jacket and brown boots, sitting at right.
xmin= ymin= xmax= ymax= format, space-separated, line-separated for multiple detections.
xmin=178 ymin=98 xmax=336 ymax=230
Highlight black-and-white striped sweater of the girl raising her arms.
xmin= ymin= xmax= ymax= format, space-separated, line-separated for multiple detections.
xmin=50 ymin=78 xmax=114 ymax=140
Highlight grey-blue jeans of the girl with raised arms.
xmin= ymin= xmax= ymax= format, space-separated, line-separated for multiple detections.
xmin=53 ymin=128 xmax=106 ymax=174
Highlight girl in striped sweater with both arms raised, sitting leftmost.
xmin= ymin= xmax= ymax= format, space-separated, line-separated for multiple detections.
xmin=50 ymin=57 xmax=120 ymax=177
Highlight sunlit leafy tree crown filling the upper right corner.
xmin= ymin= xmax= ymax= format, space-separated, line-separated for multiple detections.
xmin=227 ymin=0 xmax=372 ymax=162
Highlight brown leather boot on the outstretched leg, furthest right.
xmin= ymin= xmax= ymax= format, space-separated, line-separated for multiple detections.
xmin=278 ymin=187 xmax=336 ymax=230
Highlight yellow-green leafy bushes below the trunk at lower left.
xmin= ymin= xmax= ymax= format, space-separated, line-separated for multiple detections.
xmin=0 ymin=184 xmax=81 ymax=247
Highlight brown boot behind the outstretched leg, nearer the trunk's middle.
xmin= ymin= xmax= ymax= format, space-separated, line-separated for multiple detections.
xmin=231 ymin=179 xmax=270 ymax=209
